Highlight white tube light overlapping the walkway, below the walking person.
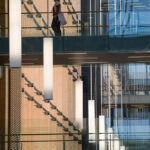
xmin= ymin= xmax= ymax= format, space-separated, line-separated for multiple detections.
xmin=43 ymin=38 xmax=53 ymax=100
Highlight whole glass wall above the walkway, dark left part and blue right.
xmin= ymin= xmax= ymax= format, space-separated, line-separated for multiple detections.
xmin=82 ymin=0 xmax=150 ymax=37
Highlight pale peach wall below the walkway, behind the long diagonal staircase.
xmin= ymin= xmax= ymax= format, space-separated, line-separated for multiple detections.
xmin=21 ymin=66 xmax=81 ymax=150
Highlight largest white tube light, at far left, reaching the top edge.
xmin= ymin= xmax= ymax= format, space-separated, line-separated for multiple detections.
xmin=9 ymin=0 xmax=22 ymax=68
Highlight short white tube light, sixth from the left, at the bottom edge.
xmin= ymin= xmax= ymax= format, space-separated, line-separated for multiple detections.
xmin=108 ymin=128 xmax=114 ymax=150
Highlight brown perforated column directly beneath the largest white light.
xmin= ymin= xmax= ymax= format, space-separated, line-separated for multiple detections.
xmin=8 ymin=69 xmax=21 ymax=150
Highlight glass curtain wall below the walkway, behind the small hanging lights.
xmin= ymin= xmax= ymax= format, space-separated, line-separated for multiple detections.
xmin=82 ymin=64 xmax=150 ymax=150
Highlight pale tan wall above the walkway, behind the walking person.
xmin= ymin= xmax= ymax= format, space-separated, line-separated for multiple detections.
xmin=22 ymin=0 xmax=81 ymax=36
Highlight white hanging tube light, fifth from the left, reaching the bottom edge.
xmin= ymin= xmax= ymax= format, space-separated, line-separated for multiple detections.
xmin=99 ymin=115 xmax=106 ymax=150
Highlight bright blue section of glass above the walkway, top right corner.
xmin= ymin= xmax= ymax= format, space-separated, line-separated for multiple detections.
xmin=108 ymin=0 xmax=150 ymax=36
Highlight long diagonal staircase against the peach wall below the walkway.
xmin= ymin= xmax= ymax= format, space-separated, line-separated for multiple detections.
xmin=22 ymin=74 xmax=82 ymax=149
